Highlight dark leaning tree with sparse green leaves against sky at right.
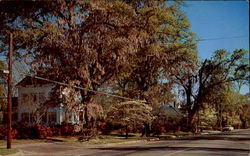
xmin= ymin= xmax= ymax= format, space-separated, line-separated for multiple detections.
xmin=173 ymin=49 xmax=249 ymax=129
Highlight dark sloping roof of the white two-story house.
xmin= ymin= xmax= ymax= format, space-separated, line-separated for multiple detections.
xmin=16 ymin=76 xmax=50 ymax=87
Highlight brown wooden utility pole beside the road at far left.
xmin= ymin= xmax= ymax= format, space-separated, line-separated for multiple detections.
xmin=7 ymin=33 xmax=13 ymax=149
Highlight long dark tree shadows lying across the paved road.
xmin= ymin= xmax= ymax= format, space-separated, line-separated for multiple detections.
xmin=93 ymin=132 xmax=250 ymax=155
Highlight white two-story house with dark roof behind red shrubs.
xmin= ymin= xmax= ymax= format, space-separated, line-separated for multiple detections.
xmin=16 ymin=76 xmax=83 ymax=125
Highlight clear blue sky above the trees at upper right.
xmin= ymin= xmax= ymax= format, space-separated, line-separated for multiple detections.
xmin=182 ymin=1 xmax=249 ymax=94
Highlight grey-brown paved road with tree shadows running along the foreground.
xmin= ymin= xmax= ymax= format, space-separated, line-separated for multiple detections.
xmin=13 ymin=130 xmax=250 ymax=156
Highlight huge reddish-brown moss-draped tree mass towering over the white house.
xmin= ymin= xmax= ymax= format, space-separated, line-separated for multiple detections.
xmin=1 ymin=0 xmax=195 ymax=128
